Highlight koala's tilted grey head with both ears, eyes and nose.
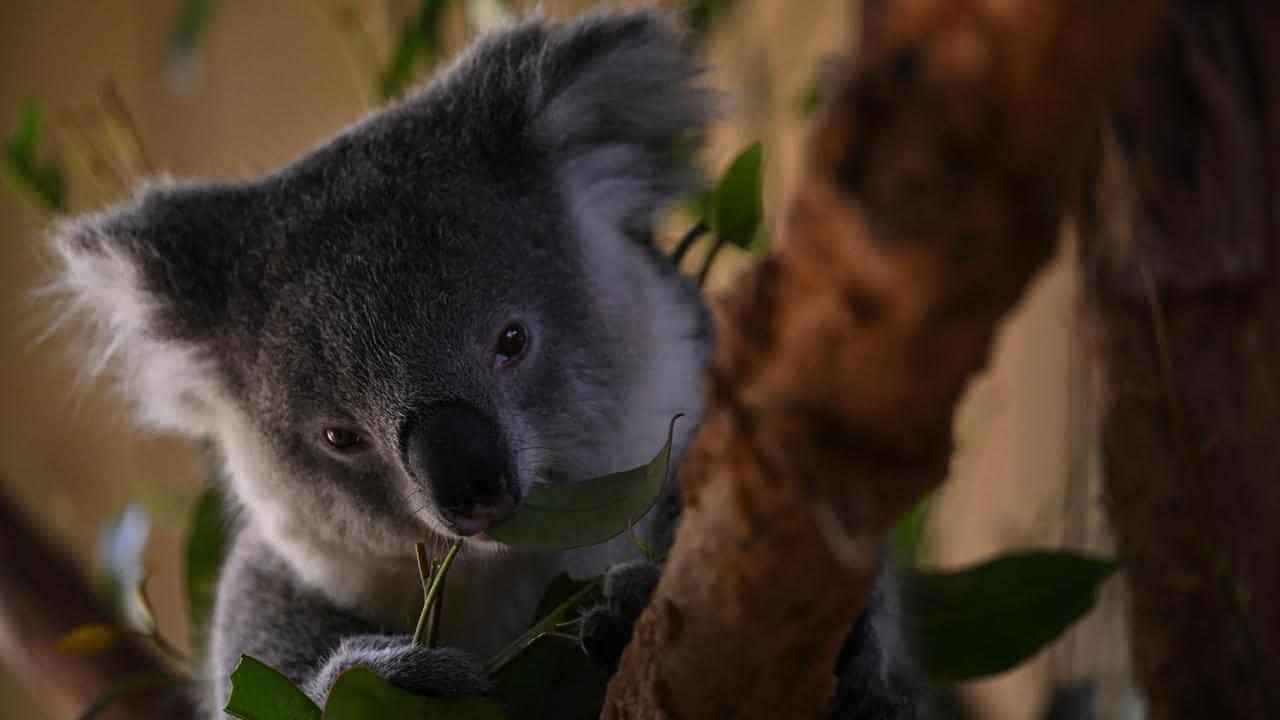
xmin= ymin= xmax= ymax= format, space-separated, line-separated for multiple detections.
xmin=58 ymin=13 xmax=708 ymax=555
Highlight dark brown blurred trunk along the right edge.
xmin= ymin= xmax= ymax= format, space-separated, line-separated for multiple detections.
xmin=1083 ymin=0 xmax=1280 ymax=720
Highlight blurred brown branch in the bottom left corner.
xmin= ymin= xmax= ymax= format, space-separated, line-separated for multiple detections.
xmin=0 ymin=486 xmax=195 ymax=720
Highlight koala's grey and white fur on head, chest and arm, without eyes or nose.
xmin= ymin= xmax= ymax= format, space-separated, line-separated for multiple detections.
xmin=58 ymin=13 xmax=709 ymax=711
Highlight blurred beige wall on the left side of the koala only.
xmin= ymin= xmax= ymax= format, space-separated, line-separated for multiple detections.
xmin=0 ymin=0 xmax=373 ymax=719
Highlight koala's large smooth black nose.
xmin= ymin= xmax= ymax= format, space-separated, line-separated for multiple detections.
xmin=402 ymin=402 xmax=520 ymax=536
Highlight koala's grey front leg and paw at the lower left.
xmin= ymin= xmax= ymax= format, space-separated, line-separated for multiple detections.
xmin=205 ymin=528 xmax=488 ymax=717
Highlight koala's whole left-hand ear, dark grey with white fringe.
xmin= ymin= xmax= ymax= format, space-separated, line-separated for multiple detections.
xmin=50 ymin=183 xmax=252 ymax=434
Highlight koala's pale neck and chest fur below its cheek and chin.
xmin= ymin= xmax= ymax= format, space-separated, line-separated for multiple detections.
xmin=219 ymin=404 xmax=660 ymax=659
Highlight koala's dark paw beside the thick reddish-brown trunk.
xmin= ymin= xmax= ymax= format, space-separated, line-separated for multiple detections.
xmin=579 ymin=562 xmax=662 ymax=673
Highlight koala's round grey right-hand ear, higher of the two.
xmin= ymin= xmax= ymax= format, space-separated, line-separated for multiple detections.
xmin=531 ymin=12 xmax=713 ymax=234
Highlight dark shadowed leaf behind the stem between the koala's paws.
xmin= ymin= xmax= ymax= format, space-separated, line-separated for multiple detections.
xmin=494 ymin=574 xmax=609 ymax=720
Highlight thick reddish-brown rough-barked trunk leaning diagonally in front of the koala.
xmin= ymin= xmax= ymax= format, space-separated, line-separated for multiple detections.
xmin=604 ymin=0 xmax=1158 ymax=719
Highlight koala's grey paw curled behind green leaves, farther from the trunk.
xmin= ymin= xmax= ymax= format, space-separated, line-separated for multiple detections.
xmin=306 ymin=635 xmax=490 ymax=705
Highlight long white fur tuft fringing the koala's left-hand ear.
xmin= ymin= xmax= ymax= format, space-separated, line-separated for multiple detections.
xmin=46 ymin=186 xmax=239 ymax=436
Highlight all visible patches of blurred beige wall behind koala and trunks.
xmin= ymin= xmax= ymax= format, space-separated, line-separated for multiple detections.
xmin=0 ymin=0 xmax=1115 ymax=717
